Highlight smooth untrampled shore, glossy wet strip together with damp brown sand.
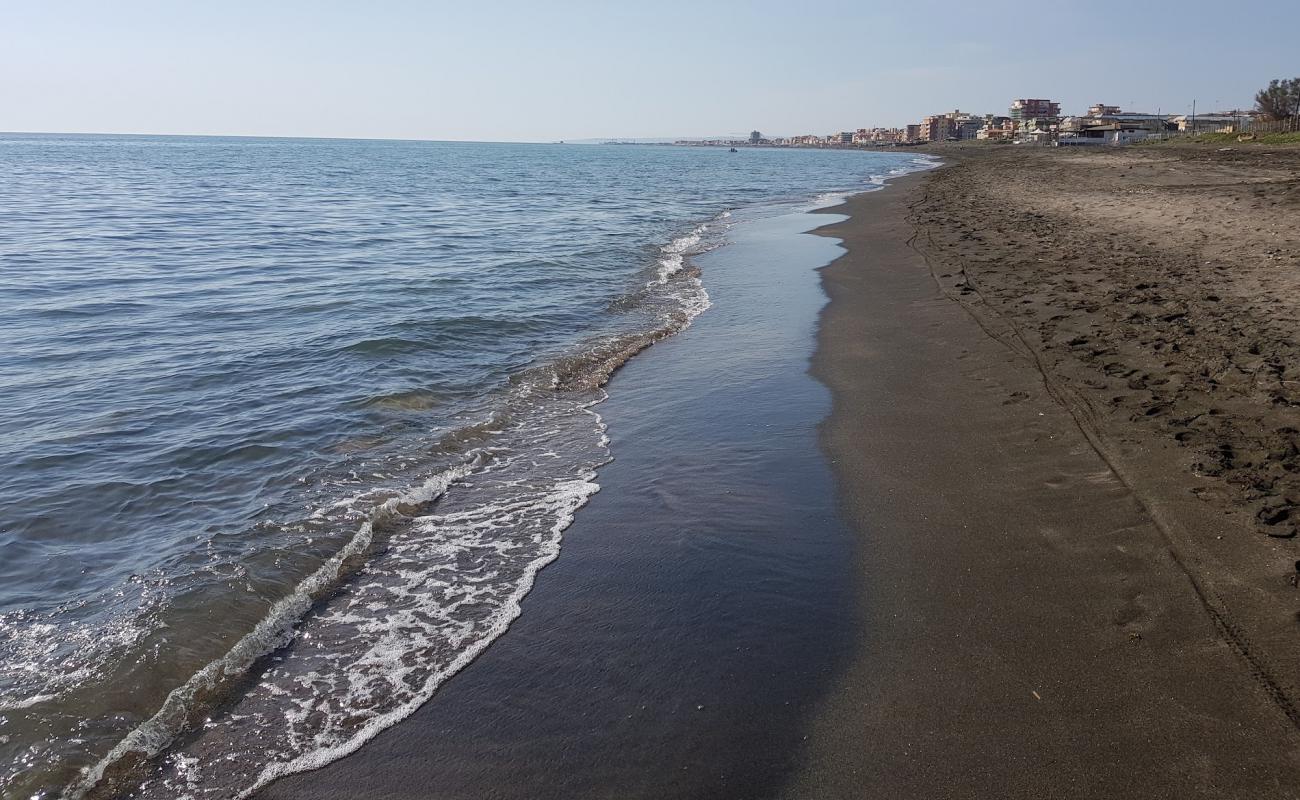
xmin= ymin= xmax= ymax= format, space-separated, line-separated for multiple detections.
xmin=131 ymin=145 xmax=1300 ymax=800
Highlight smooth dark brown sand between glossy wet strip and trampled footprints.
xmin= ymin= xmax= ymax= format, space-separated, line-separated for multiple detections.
xmin=783 ymin=165 xmax=1300 ymax=799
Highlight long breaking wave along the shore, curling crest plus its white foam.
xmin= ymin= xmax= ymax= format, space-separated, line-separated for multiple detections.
xmin=62 ymin=225 xmax=710 ymax=800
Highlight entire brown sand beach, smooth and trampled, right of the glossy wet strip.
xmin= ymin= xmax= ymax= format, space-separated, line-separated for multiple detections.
xmin=784 ymin=147 xmax=1300 ymax=797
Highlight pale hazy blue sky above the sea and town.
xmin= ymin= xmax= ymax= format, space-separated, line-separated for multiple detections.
xmin=0 ymin=0 xmax=1300 ymax=142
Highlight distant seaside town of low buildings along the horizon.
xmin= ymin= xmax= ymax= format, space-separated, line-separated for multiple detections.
xmin=673 ymin=99 xmax=1273 ymax=148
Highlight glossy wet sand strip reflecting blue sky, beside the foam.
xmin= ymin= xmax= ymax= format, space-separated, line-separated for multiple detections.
xmin=259 ymin=197 xmax=861 ymax=800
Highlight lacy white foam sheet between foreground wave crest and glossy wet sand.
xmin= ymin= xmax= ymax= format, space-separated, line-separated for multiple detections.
xmin=105 ymin=390 xmax=608 ymax=800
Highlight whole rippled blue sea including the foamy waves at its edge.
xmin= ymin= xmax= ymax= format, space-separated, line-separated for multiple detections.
xmin=0 ymin=134 xmax=918 ymax=797
